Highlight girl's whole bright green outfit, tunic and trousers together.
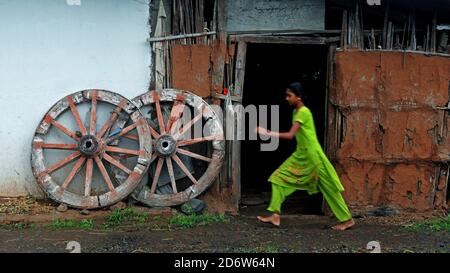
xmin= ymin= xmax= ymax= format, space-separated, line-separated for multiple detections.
xmin=268 ymin=106 xmax=352 ymax=222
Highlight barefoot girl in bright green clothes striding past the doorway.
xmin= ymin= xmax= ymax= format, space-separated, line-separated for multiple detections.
xmin=256 ymin=82 xmax=355 ymax=230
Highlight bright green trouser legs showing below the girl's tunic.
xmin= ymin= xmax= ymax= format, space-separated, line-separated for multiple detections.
xmin=267 ymin=183 xmax=352 ymax=222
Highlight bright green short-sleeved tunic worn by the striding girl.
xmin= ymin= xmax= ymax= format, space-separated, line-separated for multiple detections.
xmin=269 ymin=106 xmax=344 ymax=194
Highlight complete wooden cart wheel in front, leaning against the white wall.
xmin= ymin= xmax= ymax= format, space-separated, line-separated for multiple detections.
xmin=31 ymin=90 xmax=151 ymax=209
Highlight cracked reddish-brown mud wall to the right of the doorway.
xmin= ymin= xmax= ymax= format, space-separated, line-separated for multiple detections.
xmin=327 ymin=51 xmax=450 ymax=211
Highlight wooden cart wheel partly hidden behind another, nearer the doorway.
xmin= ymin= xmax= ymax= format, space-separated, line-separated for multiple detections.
xmin=132 ymin=89 xmax=225 ymax=207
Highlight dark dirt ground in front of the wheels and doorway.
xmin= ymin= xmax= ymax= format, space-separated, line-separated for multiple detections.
xmin=0 ymin=196 xmax=450 ymax=253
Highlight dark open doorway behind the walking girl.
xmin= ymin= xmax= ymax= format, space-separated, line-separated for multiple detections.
xmin=241 ymin=43 xmax=328 ymax=214
